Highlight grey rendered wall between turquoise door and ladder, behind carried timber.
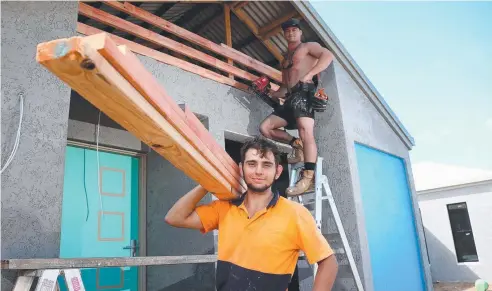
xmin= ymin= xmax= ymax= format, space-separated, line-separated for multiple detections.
xmin=137 ymin=55 xmax=268 ymax=291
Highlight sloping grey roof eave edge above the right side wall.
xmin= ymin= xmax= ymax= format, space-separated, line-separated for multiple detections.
xmin=291 ymin=1 xmax=415 ymax=150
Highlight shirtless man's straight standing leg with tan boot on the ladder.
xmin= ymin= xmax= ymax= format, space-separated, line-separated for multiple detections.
xmin=286 ymin=117 xmax=318 ymax=196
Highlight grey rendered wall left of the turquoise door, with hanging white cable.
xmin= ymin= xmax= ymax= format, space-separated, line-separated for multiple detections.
xmin=1 ymin=1 xmax=77 ymax=290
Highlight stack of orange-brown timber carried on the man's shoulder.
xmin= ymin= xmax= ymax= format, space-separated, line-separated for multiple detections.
xmin=36 ymin=33 xmax=245 ymax=199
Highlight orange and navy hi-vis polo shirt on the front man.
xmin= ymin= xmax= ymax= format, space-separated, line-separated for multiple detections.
xmin=196 ymin=193 xmax=333 ymax=291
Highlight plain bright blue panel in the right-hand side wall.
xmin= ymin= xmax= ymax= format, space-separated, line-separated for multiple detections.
xmin=355 ymin=144 xmax=426 ymax=291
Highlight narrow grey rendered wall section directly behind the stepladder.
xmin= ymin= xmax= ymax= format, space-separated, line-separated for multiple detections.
xmin=299 ymin=64 xmax=360 ymax=291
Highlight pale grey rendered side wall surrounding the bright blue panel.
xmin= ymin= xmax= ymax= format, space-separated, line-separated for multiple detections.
xmin=335 ymin=62 xmax=432 ymax=291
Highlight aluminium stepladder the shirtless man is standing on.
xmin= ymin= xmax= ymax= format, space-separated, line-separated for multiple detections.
xmin=289 ymin=157 xmax=364 ymax=291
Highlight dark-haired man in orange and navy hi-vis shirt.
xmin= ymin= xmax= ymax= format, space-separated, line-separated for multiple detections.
xmin=166 ymin=138 xmax=338 ymax=291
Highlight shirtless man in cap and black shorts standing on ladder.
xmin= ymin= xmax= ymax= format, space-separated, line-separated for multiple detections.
xmin=260 ymin=19 xmax=333 ymax=196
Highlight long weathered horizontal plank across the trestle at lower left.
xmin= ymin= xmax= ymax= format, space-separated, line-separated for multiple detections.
xmin=1 ymin=255 xmax=217 ymax=270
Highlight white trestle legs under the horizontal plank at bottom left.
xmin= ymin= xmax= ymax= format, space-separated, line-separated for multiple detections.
xmin=13 ymin=269 xmax=85 ymax=291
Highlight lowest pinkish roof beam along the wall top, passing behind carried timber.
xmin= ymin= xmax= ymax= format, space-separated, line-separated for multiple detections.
xmin=77 ymin=22 xmax=252 ymax=92
